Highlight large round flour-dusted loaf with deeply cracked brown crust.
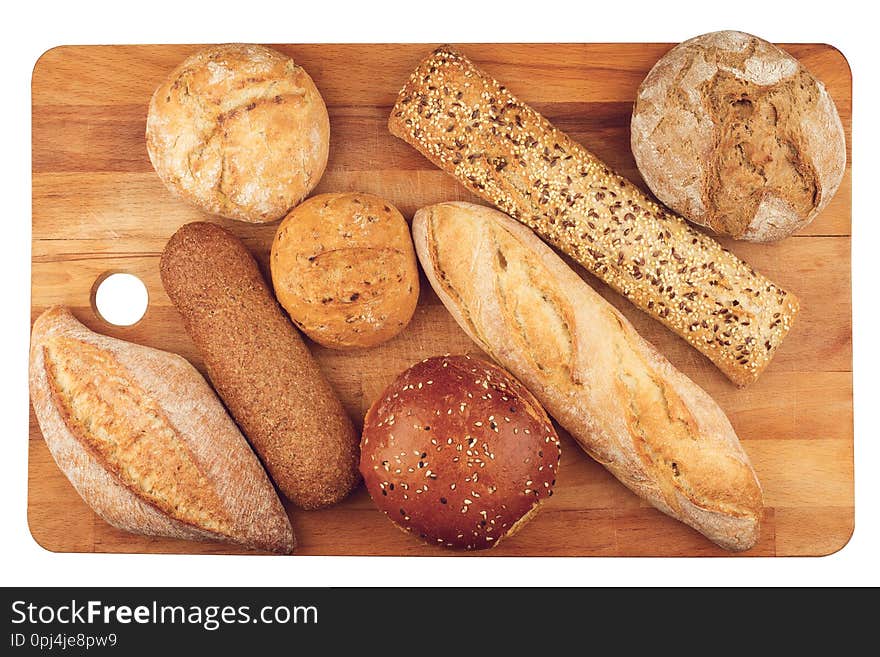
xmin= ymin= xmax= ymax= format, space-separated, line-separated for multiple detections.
xmin=631 ymin=31 xmax=846 ymax=242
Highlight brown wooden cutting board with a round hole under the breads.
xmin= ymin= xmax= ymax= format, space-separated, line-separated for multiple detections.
xmin=28 ymin=44 xmax=853 ymax=555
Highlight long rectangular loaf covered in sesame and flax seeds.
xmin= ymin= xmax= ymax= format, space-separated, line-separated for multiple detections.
xmin=388 ymin=46 xmax=798 ymax=386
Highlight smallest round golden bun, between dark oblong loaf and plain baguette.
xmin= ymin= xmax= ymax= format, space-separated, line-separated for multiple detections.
xmin=270 ymin=193 xmax=419 ymax=349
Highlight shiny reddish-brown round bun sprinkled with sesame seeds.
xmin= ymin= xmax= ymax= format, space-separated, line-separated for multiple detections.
xmin=360 ymin=356 xmax=560 ymax=550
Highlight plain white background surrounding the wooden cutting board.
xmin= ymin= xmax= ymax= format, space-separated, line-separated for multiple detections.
xmin=0 ymin=0 xmax=880 ymax=586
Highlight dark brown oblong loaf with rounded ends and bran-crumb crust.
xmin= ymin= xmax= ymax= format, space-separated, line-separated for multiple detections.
xmin=160 ymin=222 xmax=358 ymax=509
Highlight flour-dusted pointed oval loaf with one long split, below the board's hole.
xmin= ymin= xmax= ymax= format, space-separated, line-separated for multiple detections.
xmin=30 ymin=306 xmax=294 ymax=554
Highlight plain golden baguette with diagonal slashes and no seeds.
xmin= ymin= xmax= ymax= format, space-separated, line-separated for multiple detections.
xmin=412 ymin=203 xmax=763 ymax=550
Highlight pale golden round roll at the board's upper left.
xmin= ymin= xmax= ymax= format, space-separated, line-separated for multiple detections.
xmin=146 ymin=44 xmax=330 ymax=223
